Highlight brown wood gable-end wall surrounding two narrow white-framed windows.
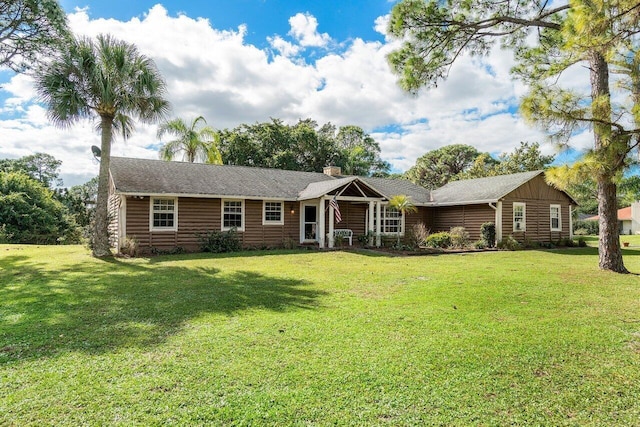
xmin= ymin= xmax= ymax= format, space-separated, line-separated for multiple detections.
xmin=502 ymin=176 xmax=572 ymax=242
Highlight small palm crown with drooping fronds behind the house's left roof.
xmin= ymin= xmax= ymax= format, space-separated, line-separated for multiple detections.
xmin=158 ymin=116 xmax=222 ymax=165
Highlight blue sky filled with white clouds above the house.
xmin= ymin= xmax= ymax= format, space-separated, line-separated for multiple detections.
xmin=0 ymin=0 xmax=592 ymax=186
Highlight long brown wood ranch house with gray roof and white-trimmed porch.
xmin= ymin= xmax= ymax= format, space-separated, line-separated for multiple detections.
xmin=109 ymin=157 xmax=576 ymax=251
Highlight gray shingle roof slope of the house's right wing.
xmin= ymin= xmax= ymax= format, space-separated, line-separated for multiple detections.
xmin=431 ymin=171 xmax=544 ymax=206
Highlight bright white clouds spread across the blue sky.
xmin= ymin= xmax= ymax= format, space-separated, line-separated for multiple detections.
xmin=0 ymin=5 xmax=588 ymax=185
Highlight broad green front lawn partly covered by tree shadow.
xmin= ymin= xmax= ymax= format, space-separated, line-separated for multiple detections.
xmin=0 ymin=245 xmax=640 ymax=426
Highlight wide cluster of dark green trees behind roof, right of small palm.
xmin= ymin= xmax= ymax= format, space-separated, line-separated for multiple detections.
xmin=219 ymin=119 xmax=390 ymax=176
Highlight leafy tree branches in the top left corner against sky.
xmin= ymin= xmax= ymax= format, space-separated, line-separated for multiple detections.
xmin=0 ymin=0 xmax=70 ymax=72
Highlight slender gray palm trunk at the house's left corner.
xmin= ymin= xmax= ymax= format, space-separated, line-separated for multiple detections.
xmin=93 ymin=116 xmax=113 ymax=257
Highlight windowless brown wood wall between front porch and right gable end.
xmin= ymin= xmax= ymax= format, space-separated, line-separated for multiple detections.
xmin=430 ymin=204 xmax=496 ymax=240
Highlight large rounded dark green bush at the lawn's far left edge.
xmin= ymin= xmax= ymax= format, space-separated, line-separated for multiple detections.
xmin=0 ymin=172 xmax=80 ymax=244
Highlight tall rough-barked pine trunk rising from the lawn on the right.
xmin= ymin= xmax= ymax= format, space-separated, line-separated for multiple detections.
xmin=589 ymin=51 xmax=629 ymax=273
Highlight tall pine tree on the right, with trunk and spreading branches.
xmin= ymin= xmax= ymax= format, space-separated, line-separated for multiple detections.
xmin=388 ymin=0 xmax=640 ymax=273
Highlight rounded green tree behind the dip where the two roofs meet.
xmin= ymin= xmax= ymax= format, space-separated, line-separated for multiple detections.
xmin=405 ymin=144 xmax=481 ymax=190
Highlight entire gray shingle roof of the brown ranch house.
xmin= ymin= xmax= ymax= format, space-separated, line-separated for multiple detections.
xmin=110 ymin=157 xmax=564 ymax=206
